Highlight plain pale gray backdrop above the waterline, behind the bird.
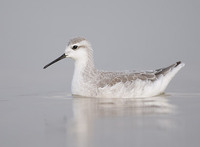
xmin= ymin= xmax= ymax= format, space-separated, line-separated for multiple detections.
xmin=0 ymin=0 xmax=200 ymax=93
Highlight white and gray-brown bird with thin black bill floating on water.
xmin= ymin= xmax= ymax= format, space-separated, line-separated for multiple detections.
xmin=44 ymin=37 xmax=185 ymax=98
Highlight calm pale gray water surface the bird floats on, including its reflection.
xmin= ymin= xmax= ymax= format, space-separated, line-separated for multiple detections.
xmin=0 ymin=92 xmax=200 ymax=147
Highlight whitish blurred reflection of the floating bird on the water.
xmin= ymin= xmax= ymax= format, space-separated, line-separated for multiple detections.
xmin=67 ymin=96 xmax=176 ymax=147
